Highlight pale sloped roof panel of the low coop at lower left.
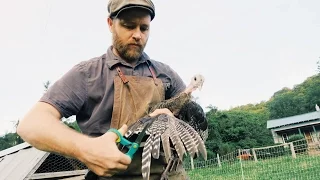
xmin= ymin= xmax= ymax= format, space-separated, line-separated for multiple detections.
xmin=0 ymin=143 xmax=49 ymax=180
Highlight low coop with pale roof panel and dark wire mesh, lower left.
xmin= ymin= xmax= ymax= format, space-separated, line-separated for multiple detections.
xmin=0 ymin=143 xmax=87 ymax=180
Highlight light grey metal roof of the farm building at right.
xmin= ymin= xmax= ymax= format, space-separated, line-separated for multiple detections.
xmin=267 ymin=111 xmax=320 ymax=129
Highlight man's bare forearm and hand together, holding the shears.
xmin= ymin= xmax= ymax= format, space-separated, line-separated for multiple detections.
xmin=17 ymin=102 xmax=131 ymax=176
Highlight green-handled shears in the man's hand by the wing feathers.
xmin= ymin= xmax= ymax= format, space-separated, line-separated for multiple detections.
xmin=108 ymin=121 xmax=153 ymax=159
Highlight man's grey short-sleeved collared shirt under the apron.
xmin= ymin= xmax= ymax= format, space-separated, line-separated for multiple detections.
xmin=40 ymin=46 xmax=186 ymax=136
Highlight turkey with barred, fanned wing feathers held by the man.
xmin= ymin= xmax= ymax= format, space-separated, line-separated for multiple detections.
xmin=125 ymin=75 xmax=208 ymax=180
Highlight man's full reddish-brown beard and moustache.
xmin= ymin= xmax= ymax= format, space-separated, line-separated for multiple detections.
xmin=113 ymin=33 xmax=145 ymax=63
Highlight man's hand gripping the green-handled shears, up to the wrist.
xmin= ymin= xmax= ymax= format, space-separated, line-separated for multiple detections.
xmin=80 ymin=125 xmax=131 ymax=176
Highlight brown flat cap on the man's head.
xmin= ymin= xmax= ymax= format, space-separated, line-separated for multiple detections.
xmin=108 ymin=0 xmax=155 ymax=20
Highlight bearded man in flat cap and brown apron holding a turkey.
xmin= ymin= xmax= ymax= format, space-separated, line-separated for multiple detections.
xmin=17 ymin=0 xmax=187 ymax=180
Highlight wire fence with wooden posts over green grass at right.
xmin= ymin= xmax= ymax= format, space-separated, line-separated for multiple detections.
xmin=185 ymin=139 xmax=320 ymax=180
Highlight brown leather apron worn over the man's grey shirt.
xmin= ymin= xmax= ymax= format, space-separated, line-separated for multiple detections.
xmin=99 ymin=64 xmax=187 ymax=180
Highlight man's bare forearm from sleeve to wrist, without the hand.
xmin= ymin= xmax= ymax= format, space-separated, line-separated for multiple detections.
xmin=17 ymin=104 xmax=89 ymax=158
